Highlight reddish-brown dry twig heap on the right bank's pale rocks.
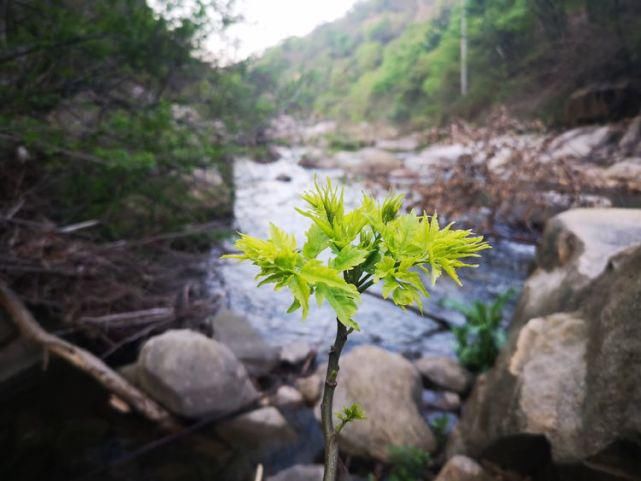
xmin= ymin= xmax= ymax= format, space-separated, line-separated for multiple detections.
xmin=413 ymin=111 xmax=641 ymax=240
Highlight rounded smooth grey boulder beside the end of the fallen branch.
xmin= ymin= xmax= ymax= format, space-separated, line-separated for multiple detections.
xmin=137 ymin=329 xmax=258 ymax=417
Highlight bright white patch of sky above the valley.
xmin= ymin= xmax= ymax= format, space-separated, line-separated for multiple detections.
xmin=207 ymin=0 xmax=358 ymax=61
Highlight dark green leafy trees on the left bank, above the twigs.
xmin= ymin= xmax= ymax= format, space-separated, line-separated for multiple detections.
xmin=0 ymin=0 xmax=264 ymax=236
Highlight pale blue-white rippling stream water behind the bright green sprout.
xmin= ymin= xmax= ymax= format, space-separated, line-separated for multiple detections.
xmin=222 ymin=147 xmax=534 ymax=355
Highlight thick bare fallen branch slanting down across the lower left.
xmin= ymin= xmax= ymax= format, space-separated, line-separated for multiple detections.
xmin=0 ymin=281 xmax=180 ymax=431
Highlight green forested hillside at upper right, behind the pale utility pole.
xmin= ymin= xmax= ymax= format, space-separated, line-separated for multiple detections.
xmin=255 ymin=0 xmax=641 ymax=125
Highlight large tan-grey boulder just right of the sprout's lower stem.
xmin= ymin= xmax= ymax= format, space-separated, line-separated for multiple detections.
xmin=316 ymin=346 xmax=436 ymax=461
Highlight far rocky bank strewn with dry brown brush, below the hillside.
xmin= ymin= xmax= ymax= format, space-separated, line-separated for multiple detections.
xmin=272 ymin=110 xmax=641 ymax=236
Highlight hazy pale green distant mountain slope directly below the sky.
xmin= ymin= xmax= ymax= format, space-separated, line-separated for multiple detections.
xmin=251 ymin=0 xmax=453 ymax=119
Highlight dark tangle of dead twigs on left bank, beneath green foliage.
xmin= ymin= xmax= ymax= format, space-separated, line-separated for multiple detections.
xmin=0 ymin=156 xmax=221 ymax=358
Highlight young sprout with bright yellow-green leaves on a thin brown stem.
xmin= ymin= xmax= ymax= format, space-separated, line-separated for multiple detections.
xmin=224 ymin=179 xmax=490 ymax=481
